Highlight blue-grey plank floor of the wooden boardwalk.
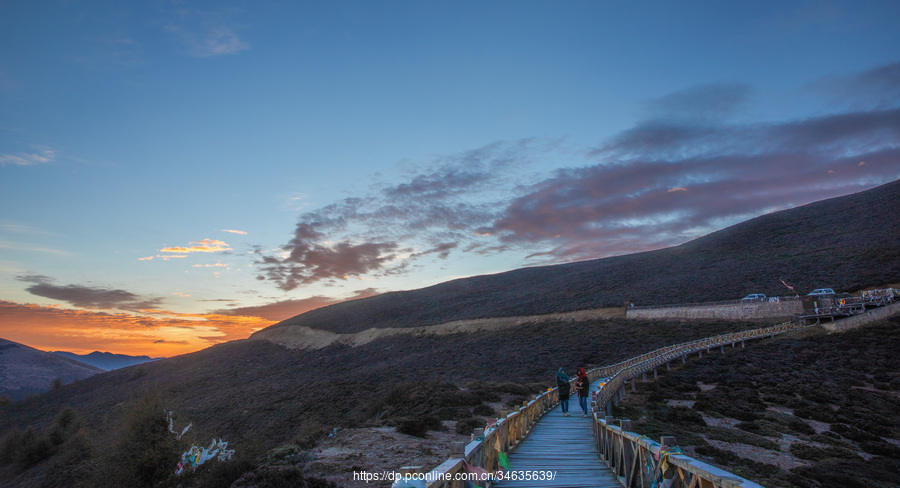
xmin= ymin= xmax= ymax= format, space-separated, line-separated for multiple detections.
xmin=494 ymin=378 xmax=622 ymax=488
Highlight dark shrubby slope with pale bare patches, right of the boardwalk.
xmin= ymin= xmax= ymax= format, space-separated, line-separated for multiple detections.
xmin=614 ymin=317 xmax=900 ymax=488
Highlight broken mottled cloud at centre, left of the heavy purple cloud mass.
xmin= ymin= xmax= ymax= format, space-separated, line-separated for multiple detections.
xmin=257 ymin=139 xmax=552 ymax=290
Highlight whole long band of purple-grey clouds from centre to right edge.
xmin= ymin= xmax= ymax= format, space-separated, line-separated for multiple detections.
xmin=256 ymin=65 xmax=900 ymax=290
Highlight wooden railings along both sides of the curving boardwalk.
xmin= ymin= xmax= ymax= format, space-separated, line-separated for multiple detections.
xmin=399 ymin=322 xmax=803 ymax=488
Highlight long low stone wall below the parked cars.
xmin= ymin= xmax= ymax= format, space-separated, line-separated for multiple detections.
xmin=625 ymin=300 xmax=803 ymax=320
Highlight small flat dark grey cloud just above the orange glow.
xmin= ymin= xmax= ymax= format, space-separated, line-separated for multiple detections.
xmin=17 ymin=275 xmax=162 ymax=310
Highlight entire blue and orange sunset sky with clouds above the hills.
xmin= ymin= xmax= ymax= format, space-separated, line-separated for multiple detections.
xmin=0 ymin=0 xmax=900 ymax=357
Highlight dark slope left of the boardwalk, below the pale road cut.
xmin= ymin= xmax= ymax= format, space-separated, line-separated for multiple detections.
xmin=0 ymin=319 xmax=756 ymax=487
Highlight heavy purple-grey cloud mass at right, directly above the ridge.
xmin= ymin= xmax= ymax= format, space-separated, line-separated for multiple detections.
xmin=493 ymin=103 xmax=900 ymax=260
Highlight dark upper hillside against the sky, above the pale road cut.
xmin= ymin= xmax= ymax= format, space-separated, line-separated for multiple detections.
xmin=260 ymin=180 xmax=900 ymax=333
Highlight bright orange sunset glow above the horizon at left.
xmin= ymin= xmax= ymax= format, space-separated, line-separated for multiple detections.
xmin=0 ymin=300 xmax=277 ymax=358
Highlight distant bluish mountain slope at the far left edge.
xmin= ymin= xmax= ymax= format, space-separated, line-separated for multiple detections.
xmin=0 ymin=339 xmax=103 ymax=400
